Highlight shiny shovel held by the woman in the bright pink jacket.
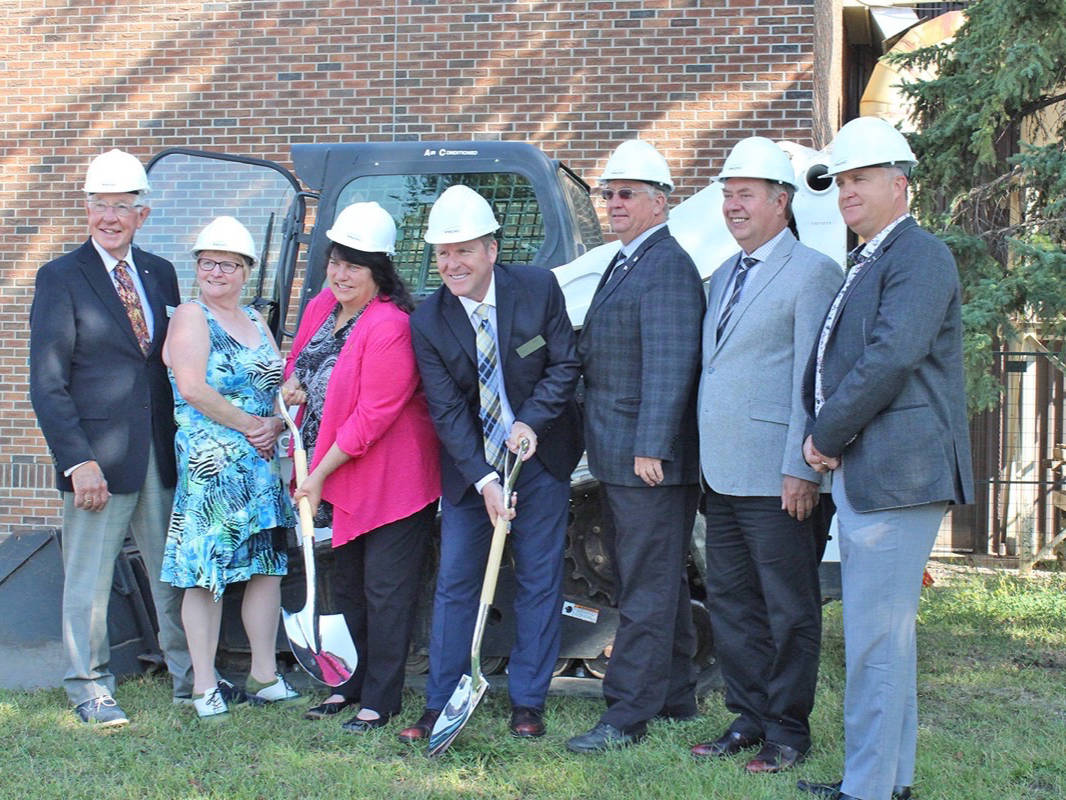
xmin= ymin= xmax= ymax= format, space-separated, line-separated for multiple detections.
xmin=277 ymin=397 xmax=359 ymax=686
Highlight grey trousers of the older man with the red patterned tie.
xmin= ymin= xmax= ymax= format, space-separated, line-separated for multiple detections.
xmin=62 ymin=443 xmax=193 ymax=705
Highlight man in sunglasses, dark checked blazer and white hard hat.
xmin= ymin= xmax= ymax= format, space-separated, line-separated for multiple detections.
xmin=567 ymin=140 xmax=704 ymax=753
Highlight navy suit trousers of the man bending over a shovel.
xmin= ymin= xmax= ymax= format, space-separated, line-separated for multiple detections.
xmin=425 ymin=455 xmax=570 ymax=708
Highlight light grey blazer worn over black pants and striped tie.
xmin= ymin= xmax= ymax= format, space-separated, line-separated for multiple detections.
xmin=699 ymin=231 xmax=843 ymax=497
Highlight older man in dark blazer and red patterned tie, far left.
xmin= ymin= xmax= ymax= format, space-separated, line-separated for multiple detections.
xmin=30 ymin=150 xmax=192 ymax=726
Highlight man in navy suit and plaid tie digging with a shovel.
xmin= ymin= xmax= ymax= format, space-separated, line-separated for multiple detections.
xmin=400 ymin=186 xmax=582 ymax=741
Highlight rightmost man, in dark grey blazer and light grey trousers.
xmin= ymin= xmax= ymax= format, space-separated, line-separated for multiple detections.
xmin=800 ymin=117 xmax=973 ymax=800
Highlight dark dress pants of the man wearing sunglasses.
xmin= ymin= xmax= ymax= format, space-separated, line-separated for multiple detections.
xmin=600 ymin=484 xmax=699 ymax=733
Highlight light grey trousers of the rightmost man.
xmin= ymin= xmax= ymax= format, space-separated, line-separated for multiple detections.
xmin=833 ymin=466 xmax=948 ymax=800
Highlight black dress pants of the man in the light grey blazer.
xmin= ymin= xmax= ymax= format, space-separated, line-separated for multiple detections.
xmin=707 ymin=490 xmax=822 ymax=752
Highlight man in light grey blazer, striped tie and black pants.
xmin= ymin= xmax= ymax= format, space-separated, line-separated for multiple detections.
xmin=692 ymin=137 xmax=843 ymax=772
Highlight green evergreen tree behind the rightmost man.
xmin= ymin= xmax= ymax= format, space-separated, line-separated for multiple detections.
xmin=895 ymin=0 xmax=1066 ymax=411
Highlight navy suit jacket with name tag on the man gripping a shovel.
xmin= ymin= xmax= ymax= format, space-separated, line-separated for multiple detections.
xmin=410 ymin=263 xmax=583 ymax=503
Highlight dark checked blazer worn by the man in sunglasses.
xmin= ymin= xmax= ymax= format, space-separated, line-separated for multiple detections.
xmin=578 ymin=227 xmax=704 ymax=486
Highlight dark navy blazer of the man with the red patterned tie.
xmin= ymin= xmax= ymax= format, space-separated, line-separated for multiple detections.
xmin=30 ymin=236 xmax=181 ymax=494
